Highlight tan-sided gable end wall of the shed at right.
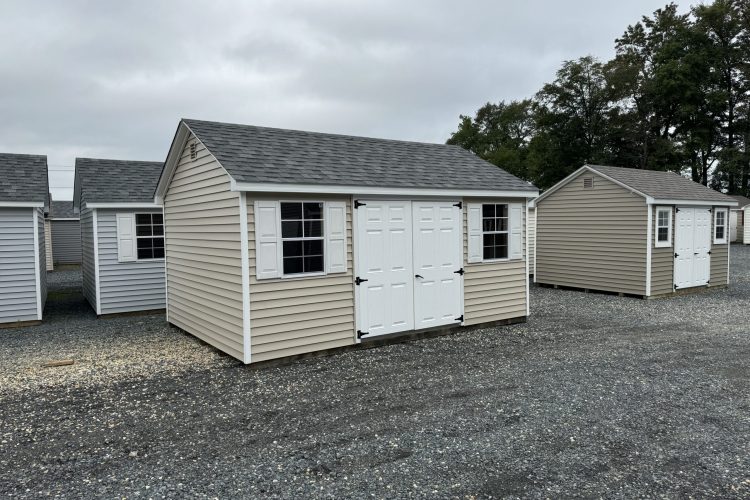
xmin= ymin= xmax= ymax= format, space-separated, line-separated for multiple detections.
xmin=535 ymin=172 xmax=648 ymax=295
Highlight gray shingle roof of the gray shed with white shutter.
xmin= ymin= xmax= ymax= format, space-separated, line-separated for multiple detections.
xmin=74 ymin=158 xmax=163 ymax=207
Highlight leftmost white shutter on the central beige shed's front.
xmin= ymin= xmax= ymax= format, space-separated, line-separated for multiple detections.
xmin=254 ymin=201 xmax=282 ymax=280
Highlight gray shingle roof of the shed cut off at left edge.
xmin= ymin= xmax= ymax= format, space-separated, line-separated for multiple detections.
xmin=0 ymin=153 xmax=49 ymax=206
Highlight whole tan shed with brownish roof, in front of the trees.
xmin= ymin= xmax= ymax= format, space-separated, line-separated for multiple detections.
xmin=534 ymin=165 xmax=737 ymax=297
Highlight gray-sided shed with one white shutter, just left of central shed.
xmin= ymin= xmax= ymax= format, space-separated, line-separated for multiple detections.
xmin=73 ymin=158 xmax=165 ymax=315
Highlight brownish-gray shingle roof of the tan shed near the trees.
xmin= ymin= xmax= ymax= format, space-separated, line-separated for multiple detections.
xmin=588 ymin=165 xmax=735 ymax=203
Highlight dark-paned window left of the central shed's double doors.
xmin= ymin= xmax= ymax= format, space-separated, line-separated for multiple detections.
xmin=281 ymin=201 xmax=324 ymax=275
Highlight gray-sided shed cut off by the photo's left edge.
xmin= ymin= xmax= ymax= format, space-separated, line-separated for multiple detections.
xmin=0 ymin=153 xmax=49 ymax=327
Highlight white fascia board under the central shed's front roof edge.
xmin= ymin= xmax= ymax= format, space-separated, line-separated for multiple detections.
xmin=231 ymin=182 xmax=539 ymax=198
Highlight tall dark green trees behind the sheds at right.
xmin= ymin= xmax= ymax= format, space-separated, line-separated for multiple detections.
xmin=447 ymin=0 xmax=750 ymax=196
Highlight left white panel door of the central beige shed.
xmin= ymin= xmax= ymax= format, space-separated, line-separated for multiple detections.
xmin=356 ymin=200 xmax=414 ymax=336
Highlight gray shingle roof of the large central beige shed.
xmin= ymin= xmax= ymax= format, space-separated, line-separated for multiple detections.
xmin=183 ymin=119 xmax=536 ymax=191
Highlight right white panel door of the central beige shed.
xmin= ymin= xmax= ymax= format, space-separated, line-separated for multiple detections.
xmin=412 ymin=201 xmax=463 ymax=329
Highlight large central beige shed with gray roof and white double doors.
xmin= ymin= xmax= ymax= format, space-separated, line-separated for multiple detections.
xmin=157 ymin=120 xmax=538 ymax=363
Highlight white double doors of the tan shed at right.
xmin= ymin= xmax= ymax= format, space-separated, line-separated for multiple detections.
xmin=674 ymin=207 xmax=711 ymax=289
